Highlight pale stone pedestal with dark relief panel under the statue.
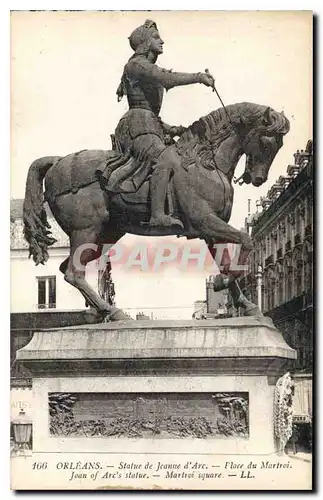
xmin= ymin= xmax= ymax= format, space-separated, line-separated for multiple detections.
xmin=17 ymin=317 xmax=296 ymax=455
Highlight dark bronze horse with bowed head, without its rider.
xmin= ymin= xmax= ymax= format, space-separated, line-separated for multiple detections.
xmin=24 ymin=103 xmax=289 ymax=322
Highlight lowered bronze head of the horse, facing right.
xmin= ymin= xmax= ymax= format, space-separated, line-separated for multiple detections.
xmin=241 ymin=108 xmax=290 ymax=187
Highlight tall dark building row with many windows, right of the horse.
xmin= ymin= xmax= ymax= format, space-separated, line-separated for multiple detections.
xmin=240 ymin=141 xmax=313 ymax=446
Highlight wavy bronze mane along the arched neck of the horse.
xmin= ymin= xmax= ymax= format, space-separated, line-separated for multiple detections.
xmin=177 ymin=102 xmax=288 ymax=170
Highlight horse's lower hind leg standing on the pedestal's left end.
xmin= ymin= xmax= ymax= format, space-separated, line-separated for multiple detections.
xmin=64 ymin=228 xmax=127 ymax=321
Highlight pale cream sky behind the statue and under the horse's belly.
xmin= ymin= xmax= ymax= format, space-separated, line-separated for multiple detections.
xmin=11 ymin=11 xmax=312 ymax=318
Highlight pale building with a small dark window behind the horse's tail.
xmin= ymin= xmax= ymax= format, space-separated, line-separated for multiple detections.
xmin=10 ymin=199 xmax=114 ymax=389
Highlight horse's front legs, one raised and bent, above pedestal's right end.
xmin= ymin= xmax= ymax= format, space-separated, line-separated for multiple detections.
xmin=202 ymin=214 xmax=262 ymax=316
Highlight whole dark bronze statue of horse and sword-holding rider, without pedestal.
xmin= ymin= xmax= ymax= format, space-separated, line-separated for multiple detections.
xmin=23 ymin=20 xmax=289 ymax=322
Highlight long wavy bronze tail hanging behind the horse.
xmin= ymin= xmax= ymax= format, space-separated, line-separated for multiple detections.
xmin=23 ymin=156 xmax=61 ymax=265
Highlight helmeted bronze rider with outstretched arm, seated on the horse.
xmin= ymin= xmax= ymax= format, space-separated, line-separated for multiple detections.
xmin=115 ymin=20 xmax=214 ymax=227
